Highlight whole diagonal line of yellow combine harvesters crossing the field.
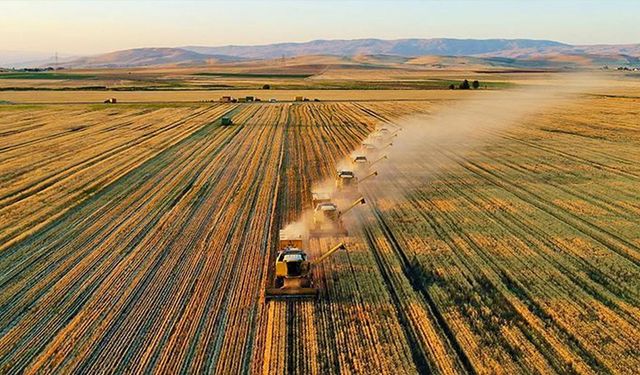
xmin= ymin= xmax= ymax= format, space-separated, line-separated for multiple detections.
xmin=265 ymin=125 xmax=402 ymax=300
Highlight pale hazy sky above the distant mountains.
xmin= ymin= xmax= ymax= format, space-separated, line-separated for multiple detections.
xmin=0 ymin=0 xmax=640 ymax=54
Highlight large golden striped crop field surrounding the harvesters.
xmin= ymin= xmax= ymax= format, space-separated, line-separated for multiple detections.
xmin=0 ymin=89 xmax=640 ymax=374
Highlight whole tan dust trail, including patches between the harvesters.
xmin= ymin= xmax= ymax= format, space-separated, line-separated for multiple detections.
xmin=286 ymin=74 xmax=603 ymax=242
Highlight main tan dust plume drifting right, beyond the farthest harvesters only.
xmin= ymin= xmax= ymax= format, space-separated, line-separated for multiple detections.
xmin=361 ymin=74 xmax=604 ymax=204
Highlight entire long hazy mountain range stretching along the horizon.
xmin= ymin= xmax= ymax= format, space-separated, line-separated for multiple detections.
xmin=40 ymin=38 xmax=640 ymax=68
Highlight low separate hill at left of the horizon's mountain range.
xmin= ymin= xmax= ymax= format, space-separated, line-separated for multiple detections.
xmin=61 ymin=48 xmax=237 ymax=68
